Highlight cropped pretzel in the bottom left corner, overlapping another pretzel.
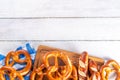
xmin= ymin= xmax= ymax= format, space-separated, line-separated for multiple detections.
xmin=0 ymin=66 xmax=24 ymax=80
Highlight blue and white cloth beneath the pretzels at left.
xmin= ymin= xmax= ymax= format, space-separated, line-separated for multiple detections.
xmin=0 ymin=43 xmax=36 ymax=80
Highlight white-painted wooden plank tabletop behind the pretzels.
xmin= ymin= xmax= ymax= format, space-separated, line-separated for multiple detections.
xmin=0 ymin=0 xmax=120 ymax=62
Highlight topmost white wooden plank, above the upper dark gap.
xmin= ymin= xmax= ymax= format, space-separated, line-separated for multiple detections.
xmin=0 ymin=0 xmax=120 ymax=17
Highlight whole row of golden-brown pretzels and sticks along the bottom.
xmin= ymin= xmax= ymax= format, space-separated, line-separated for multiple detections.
xmin=0 ymin=50 xmax=120 ymax=80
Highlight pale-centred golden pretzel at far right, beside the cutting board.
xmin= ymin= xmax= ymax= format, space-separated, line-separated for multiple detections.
xmin=100 ymin=60 xmax=120 ymax=80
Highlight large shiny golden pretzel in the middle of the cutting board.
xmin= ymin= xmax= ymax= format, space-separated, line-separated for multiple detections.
xmin=43 ymin=51 xmax=72 ymax=80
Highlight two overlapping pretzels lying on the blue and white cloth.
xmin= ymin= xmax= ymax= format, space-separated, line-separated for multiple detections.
xmin=0 ymin=50 xmax=32 ymax=80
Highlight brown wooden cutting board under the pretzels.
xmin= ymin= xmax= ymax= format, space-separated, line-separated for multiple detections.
xmin=33 ymin=45 xmax=104 ymax=69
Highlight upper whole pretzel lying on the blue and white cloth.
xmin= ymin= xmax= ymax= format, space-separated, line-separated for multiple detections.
xmin=5 ymin=50 xmax=32 ymax=75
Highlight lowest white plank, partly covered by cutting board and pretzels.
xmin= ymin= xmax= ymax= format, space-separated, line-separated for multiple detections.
xmin=0 ymin=41 xmax=120 ymax=62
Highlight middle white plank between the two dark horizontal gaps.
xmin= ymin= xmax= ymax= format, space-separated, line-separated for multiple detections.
xmin=0 ymin=18 xmax=120 ymax=40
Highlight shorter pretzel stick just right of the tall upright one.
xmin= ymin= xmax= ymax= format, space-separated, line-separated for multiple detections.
xmin=89 ymin=60 xmax=101 ymax=80
